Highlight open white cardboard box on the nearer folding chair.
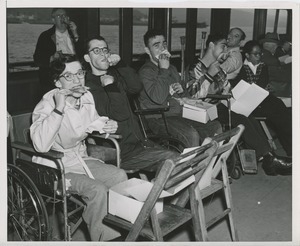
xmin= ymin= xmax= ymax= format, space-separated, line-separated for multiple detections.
xmin=108 ymin=171 xmax=195 ymax=223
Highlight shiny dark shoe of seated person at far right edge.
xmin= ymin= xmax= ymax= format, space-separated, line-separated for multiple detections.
xmin=262 ymin=153 xmax=292 ymax=176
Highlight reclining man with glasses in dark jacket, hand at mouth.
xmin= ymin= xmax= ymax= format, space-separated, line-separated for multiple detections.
xmin=84 ymin=36 xmax=177 ymax=172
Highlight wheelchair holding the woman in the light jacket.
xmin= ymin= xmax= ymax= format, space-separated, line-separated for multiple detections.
xmin=7 ymin=113 xmax=120 ymax=241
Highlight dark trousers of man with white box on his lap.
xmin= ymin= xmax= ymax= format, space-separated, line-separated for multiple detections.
xmin=148 ymin=116 xmax=222 ymax=147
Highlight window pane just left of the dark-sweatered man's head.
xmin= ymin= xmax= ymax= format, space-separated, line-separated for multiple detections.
xmin=132 ymin=8 xmax=149 ymax=54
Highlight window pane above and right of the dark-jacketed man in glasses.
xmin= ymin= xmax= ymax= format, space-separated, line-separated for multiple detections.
xmin=99 ymin=8 xmax=120 ymax=54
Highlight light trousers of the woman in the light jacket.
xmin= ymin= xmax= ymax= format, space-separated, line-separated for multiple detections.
xmin=66 ymin=160 xmax=127 ymax=241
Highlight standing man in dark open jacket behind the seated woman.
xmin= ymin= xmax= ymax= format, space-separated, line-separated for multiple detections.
xmin=33 ymin=8 xmax=83 ymax=95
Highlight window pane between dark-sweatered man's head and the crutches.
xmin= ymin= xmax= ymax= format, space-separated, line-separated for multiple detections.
xmin=171 ymin=9 xmax=186 ymax=51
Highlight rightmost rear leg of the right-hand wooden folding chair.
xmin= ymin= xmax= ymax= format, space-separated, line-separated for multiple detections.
xmin=221 ymin=159 xmax=239 ymax=241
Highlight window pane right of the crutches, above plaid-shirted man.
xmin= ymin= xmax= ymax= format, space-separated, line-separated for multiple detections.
xmin=196 ymin=9 xmax=211 ymax=50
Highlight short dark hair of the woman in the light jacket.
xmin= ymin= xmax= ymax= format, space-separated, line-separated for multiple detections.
xmin=50 ymin=54 xmax=79 ymax=82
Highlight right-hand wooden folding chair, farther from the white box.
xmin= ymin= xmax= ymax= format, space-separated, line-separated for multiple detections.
xmin=176 ymin=125 xmax=245 ymax=241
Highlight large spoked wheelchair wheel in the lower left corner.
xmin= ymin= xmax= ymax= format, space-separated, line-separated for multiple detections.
xmin=7 ymin=164 xmax=49 ymax=241
